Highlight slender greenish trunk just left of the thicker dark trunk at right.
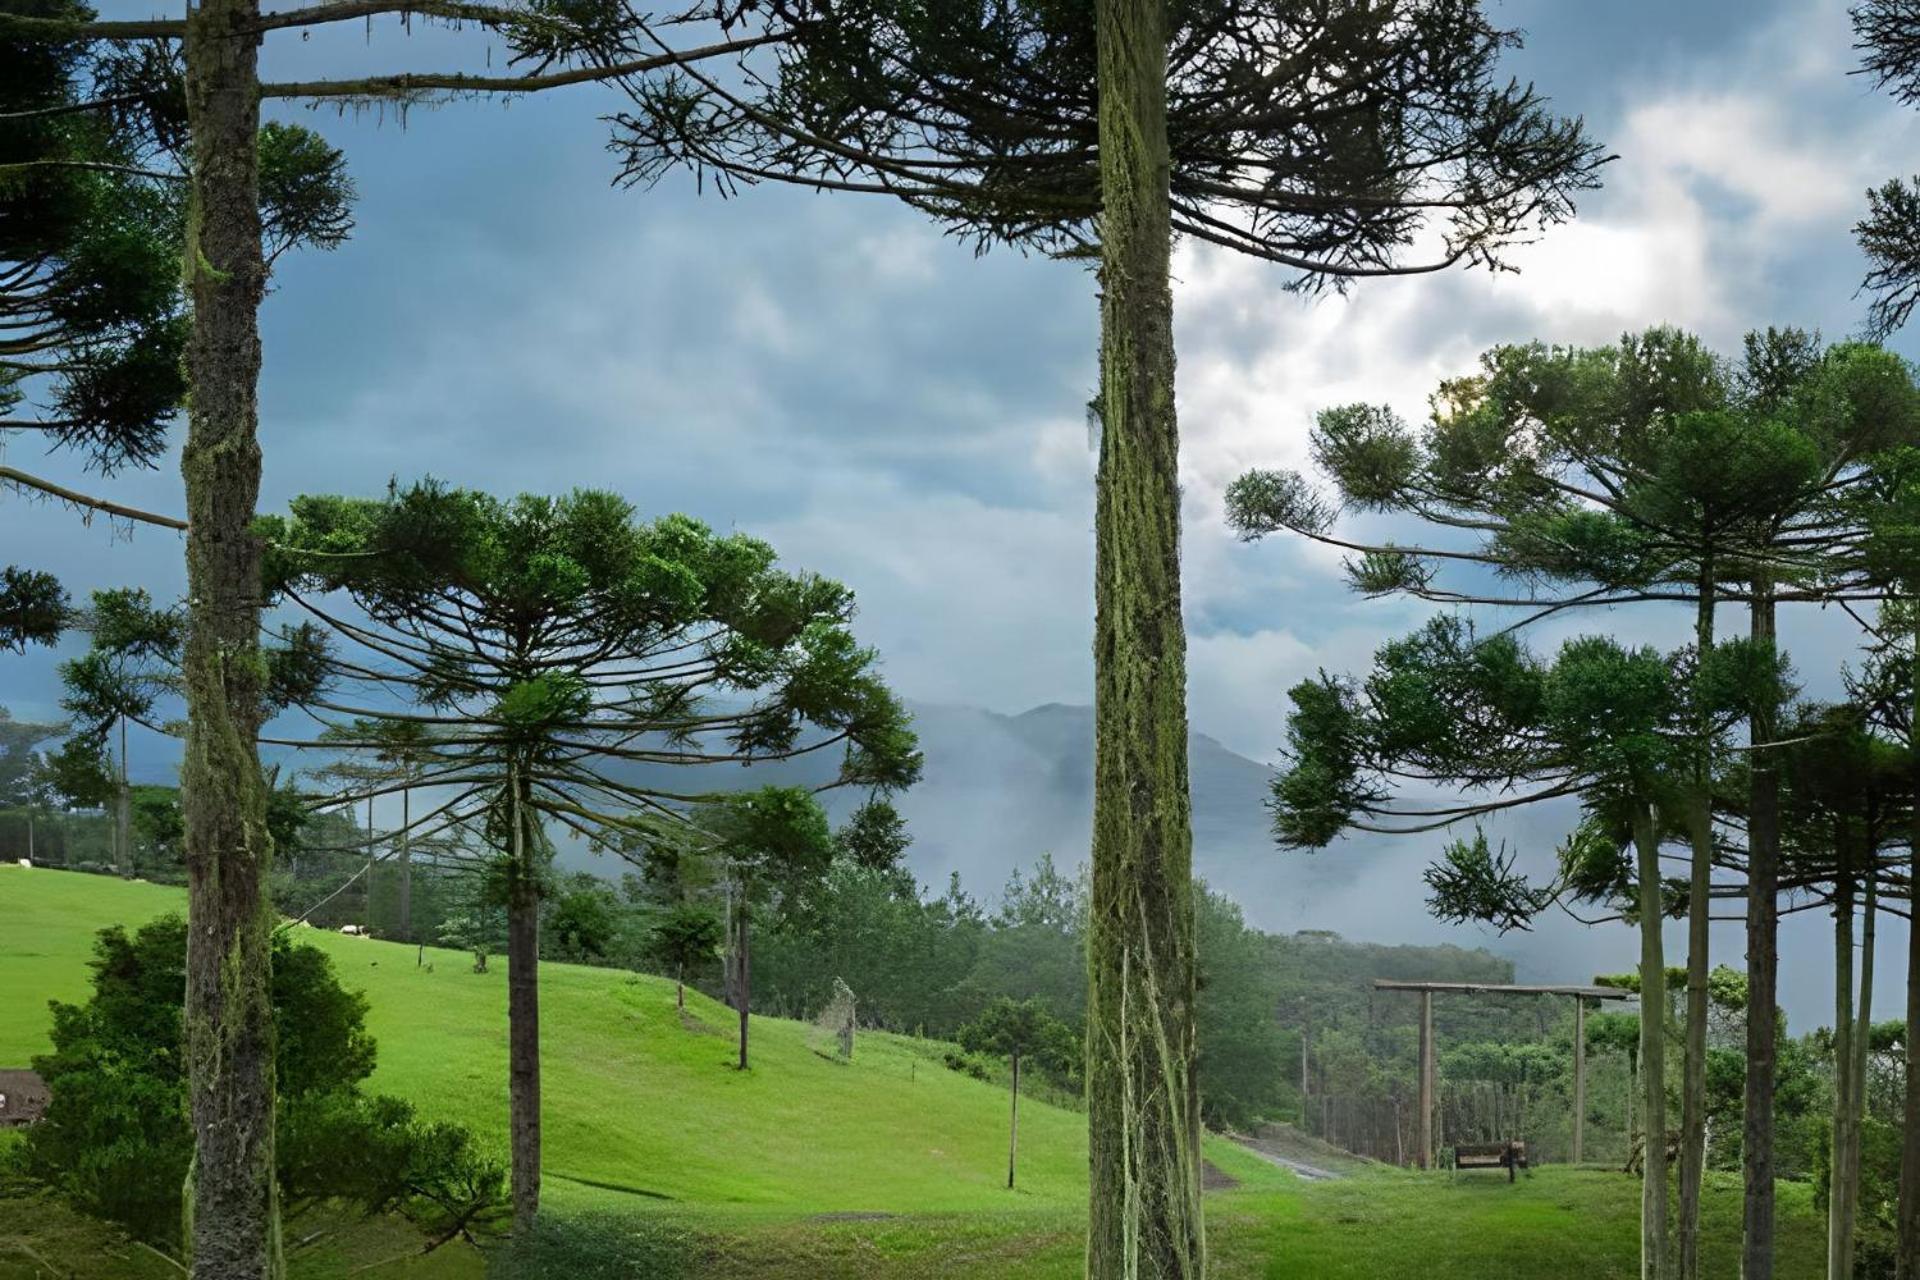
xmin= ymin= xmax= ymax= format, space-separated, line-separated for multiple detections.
xmin=1678 ymin=553 xmax=1716 ymax=1280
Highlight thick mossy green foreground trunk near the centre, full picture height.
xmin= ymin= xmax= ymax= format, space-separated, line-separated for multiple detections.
xmin=1087 ymin=0 xmax=1206 ymax=1280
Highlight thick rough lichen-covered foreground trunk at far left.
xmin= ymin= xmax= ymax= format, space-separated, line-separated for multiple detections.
xmin=180 ymin=0 xmax=284 ymax=1280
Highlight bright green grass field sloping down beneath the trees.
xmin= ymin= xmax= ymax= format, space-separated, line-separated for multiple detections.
xmin=0 ymin=867 xmax=1822 ymax=1280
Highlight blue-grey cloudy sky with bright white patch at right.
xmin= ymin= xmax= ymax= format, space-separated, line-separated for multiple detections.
xmin=0 ymin=0 xmax=1920 ymax=1020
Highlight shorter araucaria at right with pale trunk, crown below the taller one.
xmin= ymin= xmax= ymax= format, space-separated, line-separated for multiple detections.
xmin=1273 ymin=616 xmax=1778 ymax=1280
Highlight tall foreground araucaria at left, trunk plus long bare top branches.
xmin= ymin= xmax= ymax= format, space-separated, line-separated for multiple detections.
xmin=0 ymin=0 xmax=814 ymax=1280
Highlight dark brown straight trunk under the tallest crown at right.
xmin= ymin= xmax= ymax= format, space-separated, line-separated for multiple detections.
xmin=1740 ymin=572 xmax=1774 ymax=1280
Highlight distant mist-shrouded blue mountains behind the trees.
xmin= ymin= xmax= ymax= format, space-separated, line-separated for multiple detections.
xmin=97 ymin=702 xmax=1820 ymax=1027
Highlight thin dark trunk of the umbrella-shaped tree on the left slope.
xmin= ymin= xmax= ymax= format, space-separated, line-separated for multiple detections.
xmin=507 ymin=771 xmax=540 ymax=1234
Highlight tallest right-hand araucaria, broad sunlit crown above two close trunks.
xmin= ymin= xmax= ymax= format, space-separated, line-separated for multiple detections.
xmin=1229 ymin=328 xmax=1920 ymax=1280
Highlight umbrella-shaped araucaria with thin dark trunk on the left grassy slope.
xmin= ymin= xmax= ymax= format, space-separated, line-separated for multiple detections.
xmin=261 ymin=484 xmax=920 ymax=1228
